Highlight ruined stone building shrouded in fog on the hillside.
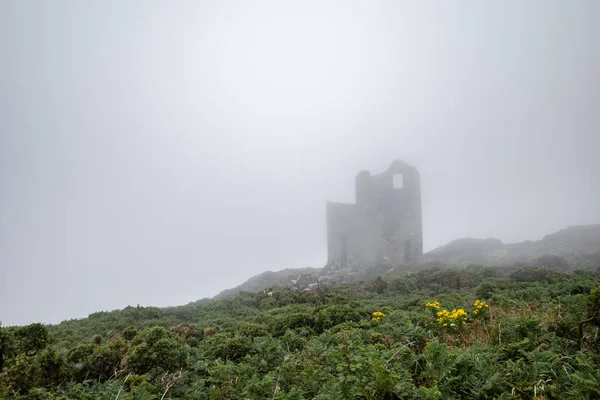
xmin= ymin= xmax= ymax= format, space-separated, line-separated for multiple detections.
xmin=327 ymin=160 xmax=423 ymax=268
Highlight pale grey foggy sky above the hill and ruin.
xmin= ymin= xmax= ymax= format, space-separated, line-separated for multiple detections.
xmin=0 ymin=0 xmax=600 ymax=325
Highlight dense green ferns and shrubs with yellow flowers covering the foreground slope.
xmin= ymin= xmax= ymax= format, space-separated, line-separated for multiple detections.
xmin=0 ymin=267 xmax=600 ymax=400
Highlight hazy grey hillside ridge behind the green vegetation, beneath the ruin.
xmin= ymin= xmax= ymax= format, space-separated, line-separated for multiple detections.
xmin=216 ymin=225 xmax=600 ymax=298
